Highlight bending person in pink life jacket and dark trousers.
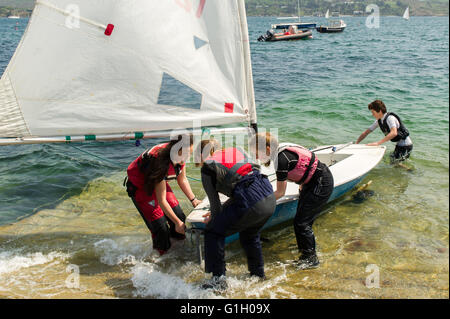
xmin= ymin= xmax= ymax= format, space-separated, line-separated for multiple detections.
xmin=250 ymin=133 xmax=334 ymax=269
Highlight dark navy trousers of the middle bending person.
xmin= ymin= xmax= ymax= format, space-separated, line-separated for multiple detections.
xmin=202 ymin=174 xmax=276 ymax=277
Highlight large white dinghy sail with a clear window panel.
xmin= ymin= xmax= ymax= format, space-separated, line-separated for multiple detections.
xmin=0 ymin=0 xmax=256 ymax=142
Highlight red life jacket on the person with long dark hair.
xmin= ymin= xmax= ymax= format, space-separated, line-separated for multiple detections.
xmin=127 ymin=143 xmax=185 ymax=188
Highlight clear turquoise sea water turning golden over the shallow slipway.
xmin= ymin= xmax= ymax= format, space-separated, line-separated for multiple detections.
xmin=0 ymin=17 xmax=449 ymax=298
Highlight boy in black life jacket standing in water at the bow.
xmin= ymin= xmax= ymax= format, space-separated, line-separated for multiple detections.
xmin=356 ymin=100 xmax=413 ymax=163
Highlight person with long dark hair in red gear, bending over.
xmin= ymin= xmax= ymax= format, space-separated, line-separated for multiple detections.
xmin=126 ymin=135 xmax=201 ymax=255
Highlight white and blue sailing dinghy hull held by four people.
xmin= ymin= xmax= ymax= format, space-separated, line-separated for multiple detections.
xmin=186 ymin=143 xmax=386 ymax=243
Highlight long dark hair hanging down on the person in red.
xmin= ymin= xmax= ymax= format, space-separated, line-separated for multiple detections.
xmin=139 ymin=135 xmax=194 ymax=196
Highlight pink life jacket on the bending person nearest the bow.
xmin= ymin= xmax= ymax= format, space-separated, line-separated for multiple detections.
xmin=277 ymin=144 xmax=319 ymax=185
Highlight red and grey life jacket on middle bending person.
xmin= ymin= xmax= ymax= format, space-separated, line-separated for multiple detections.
xmin=203 ymin=147 xmax=260 ymax=197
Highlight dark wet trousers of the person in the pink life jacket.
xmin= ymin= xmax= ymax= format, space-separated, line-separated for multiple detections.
xmin=294 ymin=162 xmax=334 ymax=255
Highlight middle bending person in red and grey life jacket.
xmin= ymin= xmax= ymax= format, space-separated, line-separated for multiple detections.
xmin=197 ymin=140 xmax=276 ymax=290
